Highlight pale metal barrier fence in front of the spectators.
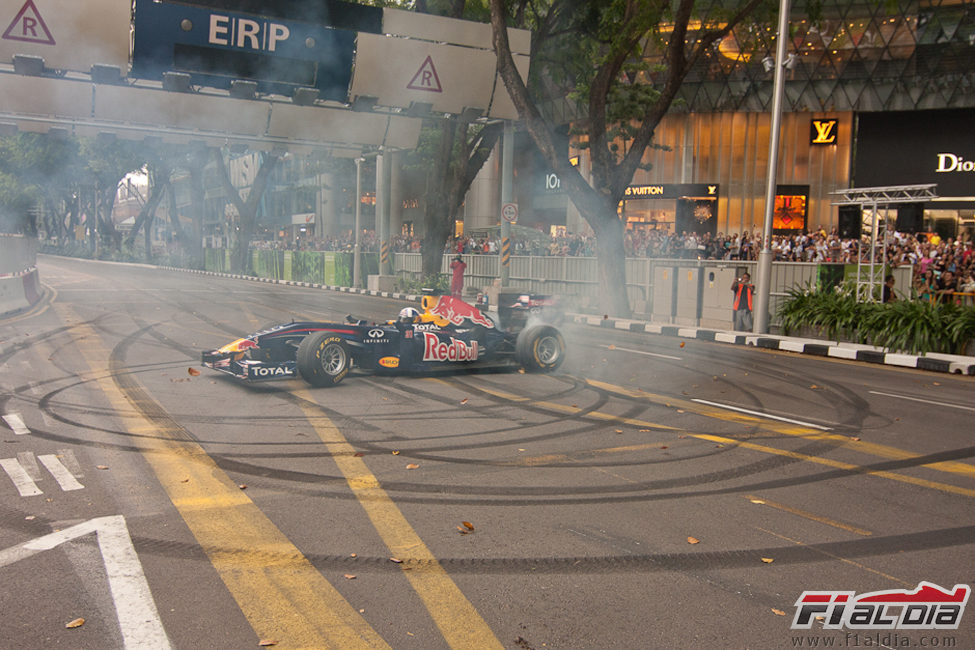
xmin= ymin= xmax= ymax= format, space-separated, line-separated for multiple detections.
xmin=196 ymin=249 xmax=912 ymax=327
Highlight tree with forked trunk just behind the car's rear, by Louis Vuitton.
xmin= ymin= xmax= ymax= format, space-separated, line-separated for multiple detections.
xmin=490 ymin=0 xmax=769 ymax=317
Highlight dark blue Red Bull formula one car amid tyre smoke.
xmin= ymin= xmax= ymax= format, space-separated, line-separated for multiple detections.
xmin=203 ymin=294 xmax=565 ymax=387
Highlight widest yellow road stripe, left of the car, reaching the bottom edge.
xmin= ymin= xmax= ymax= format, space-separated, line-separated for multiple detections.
xmin=55 ymin=306 xmax=389 ymax=649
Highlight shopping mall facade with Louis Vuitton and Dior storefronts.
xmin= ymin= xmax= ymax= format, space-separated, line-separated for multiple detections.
xmin=456 ymin=0 xmax=975 ymax=238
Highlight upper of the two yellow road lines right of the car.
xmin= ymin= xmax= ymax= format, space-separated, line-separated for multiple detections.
xmin=587 ymin=380 xmax=975 ymax=478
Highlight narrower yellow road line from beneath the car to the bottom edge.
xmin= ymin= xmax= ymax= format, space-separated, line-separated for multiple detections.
xmin=295 ymin=390 xmax=503 ymax=648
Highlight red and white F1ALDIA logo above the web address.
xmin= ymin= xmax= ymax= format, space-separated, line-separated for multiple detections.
xmin=792 ymin=582 xmax=972 ymax=630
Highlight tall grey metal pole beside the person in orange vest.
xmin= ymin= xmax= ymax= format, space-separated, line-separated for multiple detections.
xmin=754 ymin=0 xmax=789 ymax=334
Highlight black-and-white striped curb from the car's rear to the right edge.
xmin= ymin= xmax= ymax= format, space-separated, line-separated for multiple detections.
xmin=569 ymin=314 xmax=975 ymax=375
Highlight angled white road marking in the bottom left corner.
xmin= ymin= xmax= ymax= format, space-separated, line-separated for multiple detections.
xmin=0 ymin=515 xmax=172 ymax=650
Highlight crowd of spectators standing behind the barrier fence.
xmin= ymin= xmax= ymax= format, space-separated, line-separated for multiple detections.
xmin=255 ymin=228 xmax=975 ymax=300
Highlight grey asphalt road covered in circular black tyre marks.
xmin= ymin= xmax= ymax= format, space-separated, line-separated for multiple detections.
xmin=0 ymin=256 xmax=975 ymax=650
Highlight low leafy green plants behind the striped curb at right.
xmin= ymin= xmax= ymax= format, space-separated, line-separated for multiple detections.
xmin=777 ymin=282 xmax=975 ymax=354
